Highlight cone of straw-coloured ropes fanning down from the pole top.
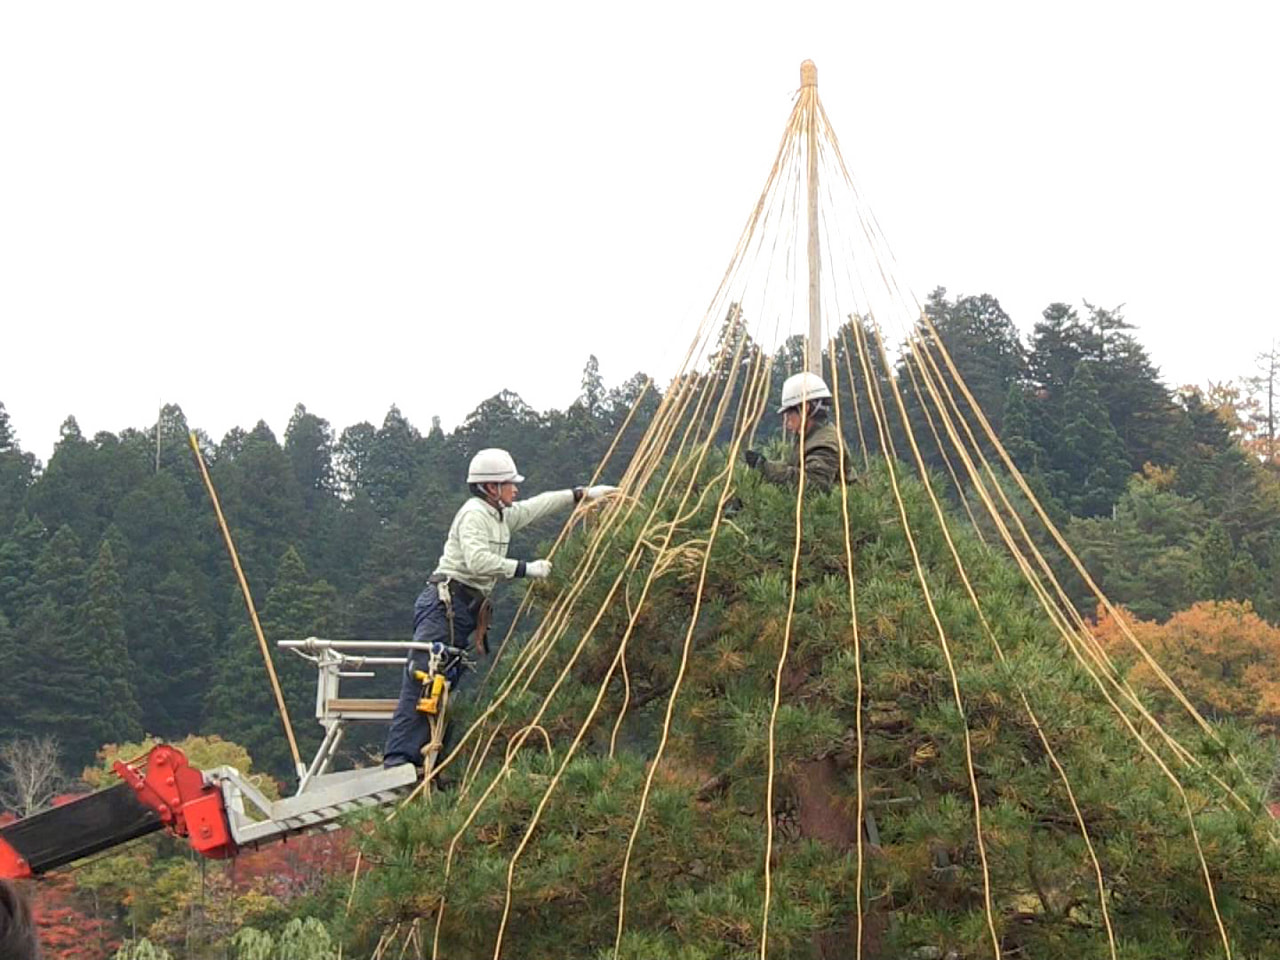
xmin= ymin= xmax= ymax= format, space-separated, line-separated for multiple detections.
xmin=363 ymin=62 xmax=1280 ymax=960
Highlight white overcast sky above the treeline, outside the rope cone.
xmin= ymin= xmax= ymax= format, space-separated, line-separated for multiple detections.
xmin=0 ymin=0 xmax=1280 ymax=460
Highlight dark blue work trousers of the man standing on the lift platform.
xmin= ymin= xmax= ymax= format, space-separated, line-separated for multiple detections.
xmin=383 ymin=584 xmax=476 ymax=767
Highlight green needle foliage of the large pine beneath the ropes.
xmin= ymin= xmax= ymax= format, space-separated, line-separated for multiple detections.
xmin=343 ymin=453 xmax=1280 ymax=960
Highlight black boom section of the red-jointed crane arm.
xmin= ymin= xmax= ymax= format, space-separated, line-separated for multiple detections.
xmin=0 ymin=783 xmax=164 ymax=874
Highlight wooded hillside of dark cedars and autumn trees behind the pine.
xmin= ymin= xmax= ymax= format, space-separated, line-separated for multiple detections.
xmin=0 ymin=289 xmax=1280 ymax=960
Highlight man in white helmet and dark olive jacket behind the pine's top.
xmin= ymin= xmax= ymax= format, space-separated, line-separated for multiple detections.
xmin=744 ymin=374 xmax=854 ymax=490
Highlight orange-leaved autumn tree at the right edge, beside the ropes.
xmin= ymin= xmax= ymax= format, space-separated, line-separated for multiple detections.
xmin=1096 ymin=600 xmax=1280 ymax=733
